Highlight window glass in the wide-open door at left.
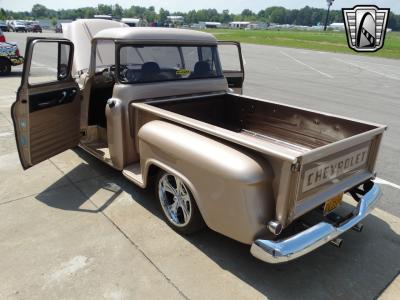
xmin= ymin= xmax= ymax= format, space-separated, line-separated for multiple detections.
xmin=28 ymin=41 xmax=72 ymax=85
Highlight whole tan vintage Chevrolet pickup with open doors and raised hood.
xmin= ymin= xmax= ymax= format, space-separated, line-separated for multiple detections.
xmin=12 ymin=20 xmax=386 ymax=263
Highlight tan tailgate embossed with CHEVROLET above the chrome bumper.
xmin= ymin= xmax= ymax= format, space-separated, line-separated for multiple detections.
xmin=288 ymin=126 xmax=386 ymax=222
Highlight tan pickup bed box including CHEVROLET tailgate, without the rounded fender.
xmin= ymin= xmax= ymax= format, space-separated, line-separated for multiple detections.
xmin=131 ymin=93 xmax=386 ymax=224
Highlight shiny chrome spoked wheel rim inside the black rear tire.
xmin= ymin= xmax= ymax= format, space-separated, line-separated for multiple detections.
xmin=158 ymin=174 xmax=192 ymax=227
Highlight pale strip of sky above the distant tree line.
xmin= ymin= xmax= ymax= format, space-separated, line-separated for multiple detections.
xmin=0 ymin=0 xmax=400 ymax=14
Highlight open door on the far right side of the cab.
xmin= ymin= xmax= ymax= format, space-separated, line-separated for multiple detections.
xmin=218 ymin=41 xmax=244 ymax=94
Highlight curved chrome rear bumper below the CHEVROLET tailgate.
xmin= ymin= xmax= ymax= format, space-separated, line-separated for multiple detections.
xmin=250 ymin=183 xmax=382 ymax=264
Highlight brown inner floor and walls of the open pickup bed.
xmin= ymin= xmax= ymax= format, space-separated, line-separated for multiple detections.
xmin=151 ymin=94 xmax=377 ymax=155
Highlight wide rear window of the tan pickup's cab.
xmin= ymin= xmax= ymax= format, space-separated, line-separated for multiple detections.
xmin=118 ymin=45 xmax=222 ymax=83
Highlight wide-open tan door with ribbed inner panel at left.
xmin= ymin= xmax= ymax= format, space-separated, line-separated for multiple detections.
xmin=11 ymin=37 xmax=81 ymax=169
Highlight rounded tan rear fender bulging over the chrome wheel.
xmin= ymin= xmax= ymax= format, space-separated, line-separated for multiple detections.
xmin=138 ymin=121 xmax=275 ymax=244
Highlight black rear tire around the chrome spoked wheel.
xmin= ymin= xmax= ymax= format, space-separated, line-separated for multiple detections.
xmin=154 ymin=170 xmax=206 ymax=235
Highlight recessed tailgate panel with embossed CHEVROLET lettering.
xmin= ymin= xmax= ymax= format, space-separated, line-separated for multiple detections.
xmin=303 ymin=147 xmax=368 ymax=192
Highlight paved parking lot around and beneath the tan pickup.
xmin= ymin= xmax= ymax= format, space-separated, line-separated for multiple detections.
xmin=0 ymin=33 xmax=400 ymax=299
